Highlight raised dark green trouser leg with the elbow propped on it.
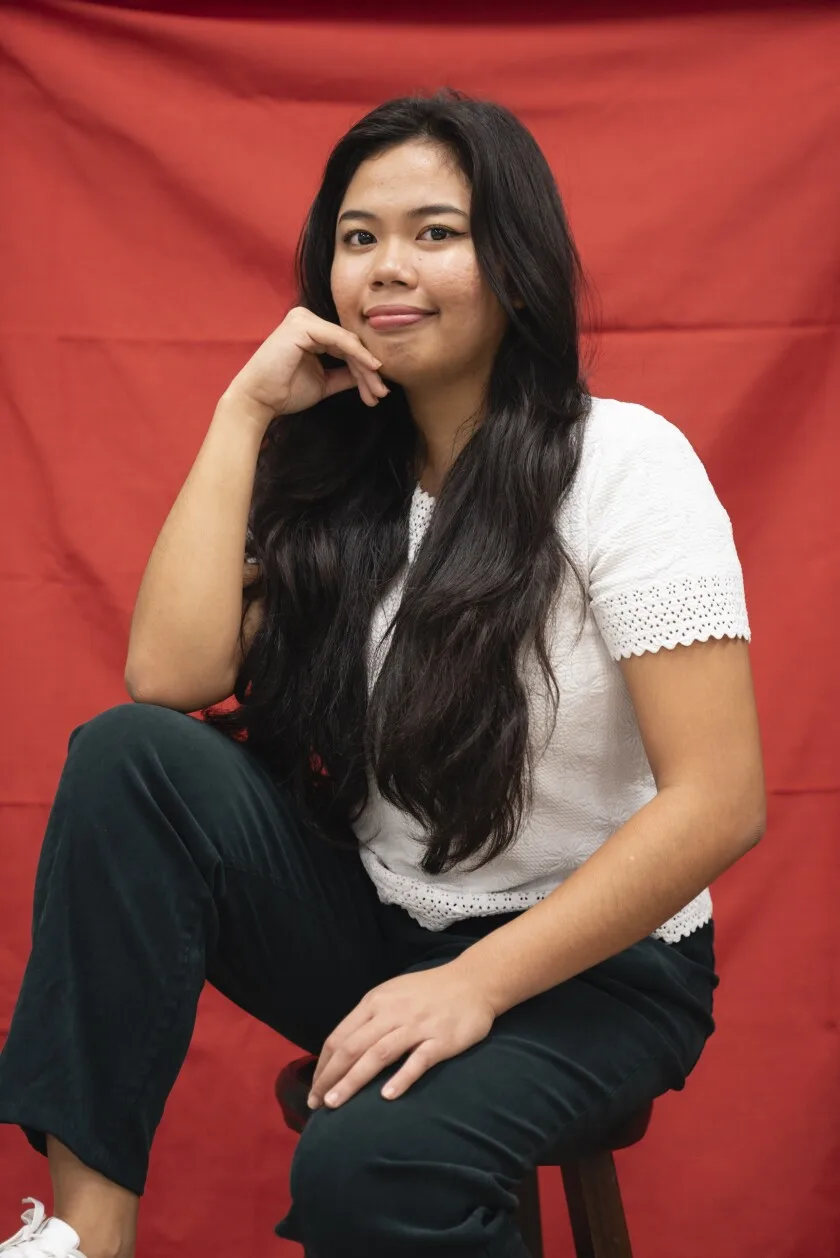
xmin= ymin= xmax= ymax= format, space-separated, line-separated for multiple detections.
xmin=0 ymin=704 xmax=389 ymax=1193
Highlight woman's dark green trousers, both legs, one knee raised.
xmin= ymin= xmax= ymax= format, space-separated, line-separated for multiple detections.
xmin=0 ymin=703 xmax=718 ymax=1258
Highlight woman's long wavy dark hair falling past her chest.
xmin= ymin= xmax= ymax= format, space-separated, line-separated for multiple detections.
xmin=204 ymin=89 xmax=591 ymax=873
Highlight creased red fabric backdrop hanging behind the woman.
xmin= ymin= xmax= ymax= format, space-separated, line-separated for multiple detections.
xmin=0 ymin=0 xmax=840 ymax=1258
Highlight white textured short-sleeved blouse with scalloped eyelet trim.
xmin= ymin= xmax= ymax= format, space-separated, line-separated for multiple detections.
xmin=355 ymin=399 xmax=749 ymax=942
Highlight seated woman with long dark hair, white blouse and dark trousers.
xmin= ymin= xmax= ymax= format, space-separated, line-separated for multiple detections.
xmin=0 ymin=93 xmax=765 ymax=1258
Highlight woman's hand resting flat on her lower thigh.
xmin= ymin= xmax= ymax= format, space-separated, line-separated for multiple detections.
xmin=309 ymin=961 xmax=495 ymax=1110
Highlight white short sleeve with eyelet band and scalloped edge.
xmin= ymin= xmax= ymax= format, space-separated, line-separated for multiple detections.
xmin=587 ymin=403 xmax=751 ymax=660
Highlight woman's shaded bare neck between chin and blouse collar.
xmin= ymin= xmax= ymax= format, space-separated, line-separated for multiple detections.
xmin=405 ymin=380 xmax=484 ymax=496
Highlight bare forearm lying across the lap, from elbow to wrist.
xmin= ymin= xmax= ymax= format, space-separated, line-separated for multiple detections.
xmin=451 ymin=788 xmax=761 ymax=1014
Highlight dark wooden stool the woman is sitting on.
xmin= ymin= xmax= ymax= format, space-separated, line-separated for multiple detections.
xmin=274 ymin=1055 xmax=653 ymax=1258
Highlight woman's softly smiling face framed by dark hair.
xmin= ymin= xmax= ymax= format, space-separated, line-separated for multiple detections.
xmin=332 ymin=141 xmax=507 ymax=389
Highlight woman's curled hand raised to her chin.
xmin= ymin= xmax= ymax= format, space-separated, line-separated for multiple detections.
xmin=225 ymin=306 xmax=389 ymax=426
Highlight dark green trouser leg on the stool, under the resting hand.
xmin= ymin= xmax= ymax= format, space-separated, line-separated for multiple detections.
xmin=277 ymin=926 xmax=717 ymax=1258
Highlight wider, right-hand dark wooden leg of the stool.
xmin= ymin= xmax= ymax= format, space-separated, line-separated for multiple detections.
xmin=561 ymin=1151 xmax=633 ymax=1258
